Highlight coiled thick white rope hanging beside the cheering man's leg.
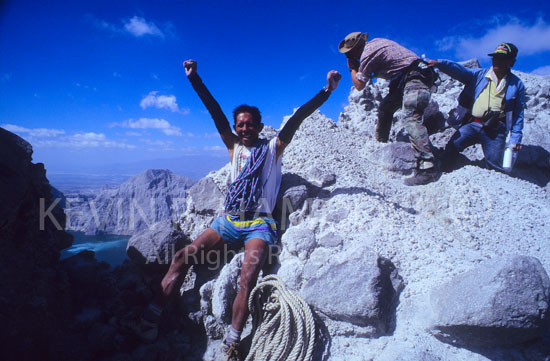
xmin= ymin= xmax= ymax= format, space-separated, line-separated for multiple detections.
xmin=245 ymin=275 xmax=315 ymax=361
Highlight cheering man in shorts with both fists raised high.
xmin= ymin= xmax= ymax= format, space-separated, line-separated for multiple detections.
xmin=133 ymin=60 xmax=341 ymax=360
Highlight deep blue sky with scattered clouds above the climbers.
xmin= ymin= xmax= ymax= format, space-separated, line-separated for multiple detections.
xmin=0 ymin=0 xmax=550 ymax=176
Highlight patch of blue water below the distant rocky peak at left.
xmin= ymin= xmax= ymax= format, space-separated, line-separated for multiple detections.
xmin=61 ymin=231 xmax=130 ymax=267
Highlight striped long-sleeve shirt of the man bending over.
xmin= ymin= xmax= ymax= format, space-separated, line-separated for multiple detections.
xmin=356 ymin=38 xmax=420 ymax=82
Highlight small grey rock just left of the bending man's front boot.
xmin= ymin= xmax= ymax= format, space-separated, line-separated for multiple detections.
xmin=370 ymin=142 xmax=416 ymax=174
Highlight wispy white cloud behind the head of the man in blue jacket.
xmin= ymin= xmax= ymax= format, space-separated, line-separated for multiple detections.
xmin=437 ymin=17 xmax=550 ymax=59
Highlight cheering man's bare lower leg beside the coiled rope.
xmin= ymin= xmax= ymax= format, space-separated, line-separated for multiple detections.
xmin=231 ymin=238 xmax=268 ymax=331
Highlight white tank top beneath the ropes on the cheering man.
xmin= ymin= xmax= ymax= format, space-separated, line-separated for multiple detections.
xmin=231 ymin=137 xmax=282 ymax=213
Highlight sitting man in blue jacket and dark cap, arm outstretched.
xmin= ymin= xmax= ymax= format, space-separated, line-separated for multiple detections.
xmin=429 ymin=43 xmax=525 ymax=171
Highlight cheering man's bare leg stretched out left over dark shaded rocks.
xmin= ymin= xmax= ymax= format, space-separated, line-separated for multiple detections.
xmin=155 ymin=228 xmax=224 ymax=306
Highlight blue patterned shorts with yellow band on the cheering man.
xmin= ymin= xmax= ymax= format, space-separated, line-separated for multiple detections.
xmin=210 ymin=214 xmax=278 ymax=248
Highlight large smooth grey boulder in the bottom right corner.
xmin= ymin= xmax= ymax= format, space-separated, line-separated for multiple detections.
xmin=432 ymin=256 xmax=550 ymax=346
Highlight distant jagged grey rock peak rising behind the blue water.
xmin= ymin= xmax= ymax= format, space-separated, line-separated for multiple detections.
xmin=66 ymin=169 xmax=194 ymax=235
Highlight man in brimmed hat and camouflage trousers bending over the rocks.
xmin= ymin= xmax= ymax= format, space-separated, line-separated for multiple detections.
xmin=338 ymin=32 xmax=441 ymax=186
